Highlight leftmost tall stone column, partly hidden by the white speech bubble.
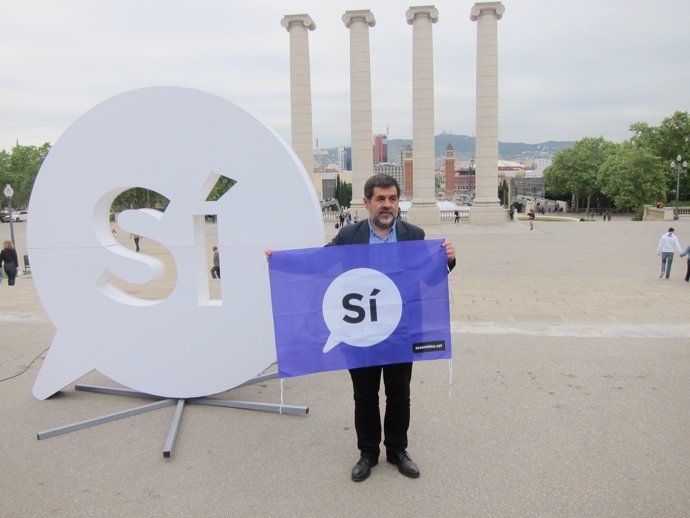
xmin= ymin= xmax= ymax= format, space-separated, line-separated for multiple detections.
xmin=280 ymin=14 xmax=323 ymax=199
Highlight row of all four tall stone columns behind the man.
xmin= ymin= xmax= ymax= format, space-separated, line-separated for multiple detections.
xmin=281 ymin=2 xmax=505 ymax=225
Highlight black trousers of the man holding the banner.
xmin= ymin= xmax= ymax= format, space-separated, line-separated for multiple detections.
xmin=350 ymin=363 xmax=412 ymax=459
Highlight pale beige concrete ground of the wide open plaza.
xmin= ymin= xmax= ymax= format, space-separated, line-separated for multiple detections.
xmin=0 ymin=218 xmax=690 ymax=518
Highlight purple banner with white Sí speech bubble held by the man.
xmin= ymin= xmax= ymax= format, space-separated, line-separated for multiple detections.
xmin=269 ymin=239 xmax=452 ymax=378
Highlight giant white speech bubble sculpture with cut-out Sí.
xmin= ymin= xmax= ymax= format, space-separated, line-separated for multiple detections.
xmin=27 ymin=87 xmax=324 ymax=399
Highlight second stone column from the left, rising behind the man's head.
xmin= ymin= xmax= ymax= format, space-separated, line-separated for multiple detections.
xmin=343 ymin=9 xmax=376 ymax=214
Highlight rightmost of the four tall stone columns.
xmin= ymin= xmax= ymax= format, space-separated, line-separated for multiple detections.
xmin=470 ymin=2 xmax=506 ymax=225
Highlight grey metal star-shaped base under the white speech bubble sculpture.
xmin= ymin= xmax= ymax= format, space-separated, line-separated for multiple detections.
xmin=36 ymin=372 xmax=309 ymax=459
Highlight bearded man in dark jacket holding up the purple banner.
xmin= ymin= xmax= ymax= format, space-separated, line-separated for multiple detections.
xmin=326 ymin=174 xmax=455 ymax=482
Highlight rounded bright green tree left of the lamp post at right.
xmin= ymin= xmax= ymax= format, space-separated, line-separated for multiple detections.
xmin=599 ymin=142 xmax=666 ymax=212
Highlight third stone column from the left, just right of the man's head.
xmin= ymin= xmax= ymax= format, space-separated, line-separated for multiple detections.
xmin=405 ymin=5 xmax=441 ymax=225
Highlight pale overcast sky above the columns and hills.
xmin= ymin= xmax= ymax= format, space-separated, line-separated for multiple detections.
xmin=0 ymin=0 xmax=690 ymax=150
